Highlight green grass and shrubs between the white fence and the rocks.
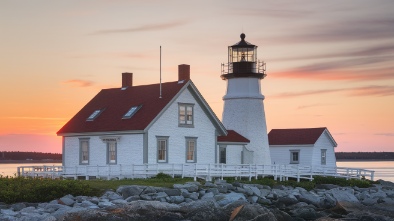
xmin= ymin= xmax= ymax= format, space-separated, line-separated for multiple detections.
xmin=0 ymin=173 xmax=374 ymax=204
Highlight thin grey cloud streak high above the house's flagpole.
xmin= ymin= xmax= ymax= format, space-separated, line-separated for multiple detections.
xmin=89 ymin=21 xmax=186 ymax=35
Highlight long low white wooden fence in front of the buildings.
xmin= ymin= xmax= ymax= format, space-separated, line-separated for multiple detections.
xmin=17 ymin=164 xmax=374 ymax=181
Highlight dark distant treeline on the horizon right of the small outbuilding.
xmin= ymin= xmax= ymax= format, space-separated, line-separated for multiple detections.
xmin=335 ymin=152 xmax=394 ymax=160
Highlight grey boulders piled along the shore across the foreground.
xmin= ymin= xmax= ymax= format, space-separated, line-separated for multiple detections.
xmin=0 ymin=180 xmax=394 ymax=221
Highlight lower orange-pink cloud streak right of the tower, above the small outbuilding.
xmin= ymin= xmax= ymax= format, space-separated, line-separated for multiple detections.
xmin=270 ymin=85 xmax=394 ymax=98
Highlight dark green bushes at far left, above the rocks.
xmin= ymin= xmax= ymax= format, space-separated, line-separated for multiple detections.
xmin=0 ymin=177 xmax=98 ymax=203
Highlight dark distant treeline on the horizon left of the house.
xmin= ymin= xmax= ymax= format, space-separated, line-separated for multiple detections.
xmin=0 ymin=151 xmax=62 ymax=160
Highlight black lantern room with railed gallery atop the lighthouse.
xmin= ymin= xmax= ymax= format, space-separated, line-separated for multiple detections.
xmin=221 ymin=33 xmax=266 ymax=80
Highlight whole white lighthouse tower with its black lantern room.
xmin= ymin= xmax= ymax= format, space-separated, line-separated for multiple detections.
xmin=221 ymin=33 xmax=271 ymax=164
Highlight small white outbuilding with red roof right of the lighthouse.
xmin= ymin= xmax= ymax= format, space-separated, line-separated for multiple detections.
xmin=268 ymin=127 xmax=337 ymax=167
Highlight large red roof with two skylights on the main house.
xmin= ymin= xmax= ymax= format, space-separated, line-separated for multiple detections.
xmin=57 ymin=81 xmax=188 ymax=134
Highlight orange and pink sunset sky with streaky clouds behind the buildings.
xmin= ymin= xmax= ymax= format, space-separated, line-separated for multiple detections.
xmin=0 ymin=0 xmax=394 ymax=153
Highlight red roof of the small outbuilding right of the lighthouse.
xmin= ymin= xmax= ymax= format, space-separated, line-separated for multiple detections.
xmin=268 ymin=127 xmax=330 ymax=146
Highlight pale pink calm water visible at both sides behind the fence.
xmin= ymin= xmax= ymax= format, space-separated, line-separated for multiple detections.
xmin=0 ymin=161 xmax=394 ymax=182
